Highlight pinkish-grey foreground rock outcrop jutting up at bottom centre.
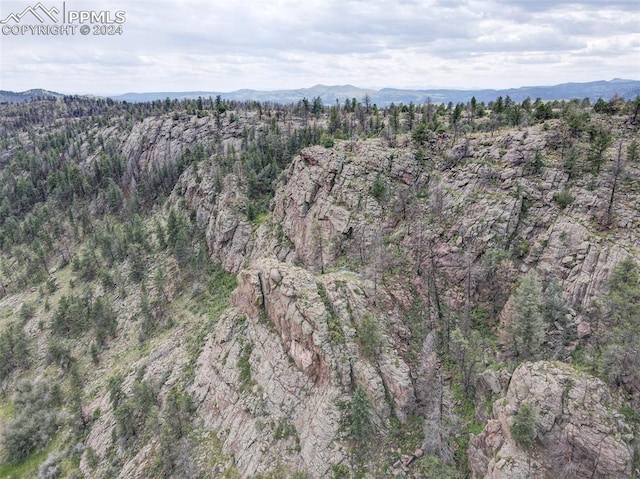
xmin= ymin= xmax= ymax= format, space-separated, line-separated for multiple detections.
xmin=194 ymin=258 xmax=416 ymax=477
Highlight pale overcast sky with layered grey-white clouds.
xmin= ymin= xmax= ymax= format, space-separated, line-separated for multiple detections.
xmin=0 ymin=0 xmax=640 ymax=95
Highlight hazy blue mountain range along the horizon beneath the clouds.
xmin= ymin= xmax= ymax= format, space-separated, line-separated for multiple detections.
xmin=0 ymin=79 xmax=640 ymax=106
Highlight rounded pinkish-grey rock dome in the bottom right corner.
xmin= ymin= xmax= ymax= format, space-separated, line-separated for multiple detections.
xmin=469 ymin=361 xmax=633 ymax=479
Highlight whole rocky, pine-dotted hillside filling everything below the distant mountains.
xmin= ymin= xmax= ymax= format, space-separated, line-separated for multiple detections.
xmin=0 ymin=92 xmax=640 ymax=479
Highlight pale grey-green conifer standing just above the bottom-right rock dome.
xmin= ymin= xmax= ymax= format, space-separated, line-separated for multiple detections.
xmin=511 ymin=270 xmax=545 ymax=359
